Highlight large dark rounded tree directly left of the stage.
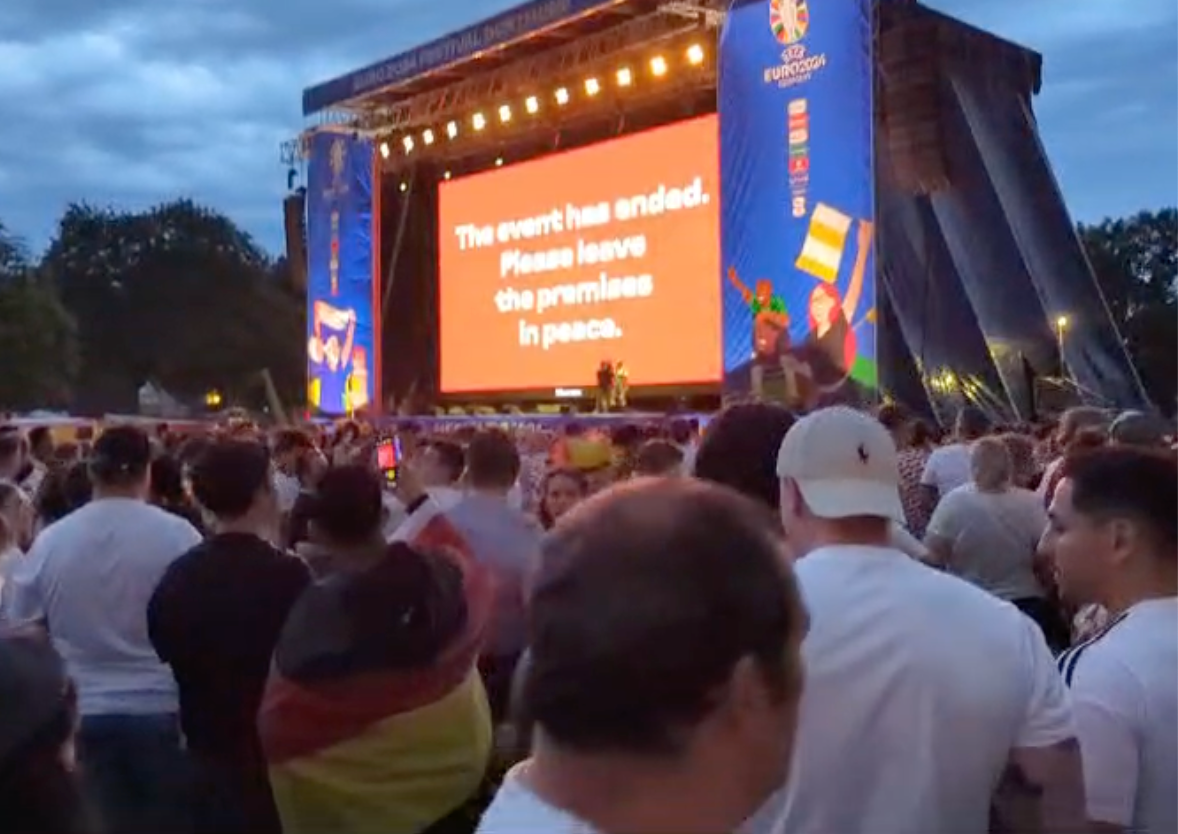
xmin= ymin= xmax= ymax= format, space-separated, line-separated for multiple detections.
xmin=44 ymin=200 xmax=304 ymax=409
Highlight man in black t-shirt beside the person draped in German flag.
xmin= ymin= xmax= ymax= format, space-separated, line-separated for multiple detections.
xmin=147 ymin=439 xmax=311 ymax=834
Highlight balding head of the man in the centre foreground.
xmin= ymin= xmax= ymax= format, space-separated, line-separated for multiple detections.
xmin=524 ymin=479 xmax=806 ymax=755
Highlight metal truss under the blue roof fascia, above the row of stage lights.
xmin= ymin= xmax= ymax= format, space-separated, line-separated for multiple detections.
xmin=279 ymin=0 xmax=724 ymax=168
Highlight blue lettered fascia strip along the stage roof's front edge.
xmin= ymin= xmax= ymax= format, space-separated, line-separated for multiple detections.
xmin=303 ymin=0 xmax=697 ymax=115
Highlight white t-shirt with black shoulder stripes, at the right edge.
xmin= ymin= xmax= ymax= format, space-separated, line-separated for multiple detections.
xmin=1059 ymin=597 xmax=1178 ymax=834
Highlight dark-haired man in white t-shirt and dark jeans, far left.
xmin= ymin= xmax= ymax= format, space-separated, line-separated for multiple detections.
xmin=2 ymin=426 xmax=200 ymax=834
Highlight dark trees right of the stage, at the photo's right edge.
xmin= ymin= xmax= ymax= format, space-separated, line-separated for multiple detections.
xmin=1078 ymin=209 xmax=1178 ymax=411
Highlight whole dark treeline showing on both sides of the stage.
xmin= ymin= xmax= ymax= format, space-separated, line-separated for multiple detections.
xmin=0 ymin=200 xmax=1178 ymax=413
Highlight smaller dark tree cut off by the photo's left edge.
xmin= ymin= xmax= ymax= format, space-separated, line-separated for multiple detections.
xmin=0 ymin=217 xmax=78 ymax=411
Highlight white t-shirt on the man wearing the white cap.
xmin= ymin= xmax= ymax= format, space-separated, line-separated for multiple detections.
xmin=742 ymin=547 xmax=1074 ymax=834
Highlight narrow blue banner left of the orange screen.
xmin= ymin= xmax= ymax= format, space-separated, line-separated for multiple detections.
xmin=306 ymin=133 xmax=378 ymax=415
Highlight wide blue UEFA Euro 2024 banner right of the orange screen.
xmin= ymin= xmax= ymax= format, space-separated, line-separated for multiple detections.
xmin=719 ymin=0 xmax=878 ymax=405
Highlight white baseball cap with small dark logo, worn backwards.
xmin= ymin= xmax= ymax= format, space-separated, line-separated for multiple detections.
xmin=777 ymin=405 xmax=905 ymax=524
